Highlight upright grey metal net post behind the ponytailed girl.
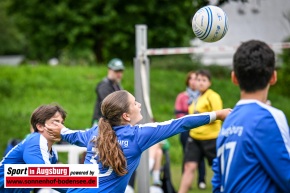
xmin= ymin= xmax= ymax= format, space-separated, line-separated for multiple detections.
xmin=134 ymin=25 xmax=152 ymax=193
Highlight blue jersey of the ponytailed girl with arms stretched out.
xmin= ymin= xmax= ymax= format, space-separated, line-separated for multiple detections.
xmin=61 ymin=112 xmax=216 ymax=193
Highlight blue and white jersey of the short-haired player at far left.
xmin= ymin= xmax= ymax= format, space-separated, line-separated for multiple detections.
xmin=0 ymin=132 xmax=58 ymax=193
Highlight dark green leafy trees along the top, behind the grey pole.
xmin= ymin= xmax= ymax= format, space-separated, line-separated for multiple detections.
xmin=3 ymin=0 xmax=208 ymax=64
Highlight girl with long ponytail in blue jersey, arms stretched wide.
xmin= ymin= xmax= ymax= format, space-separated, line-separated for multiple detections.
xmin=48 ymin=90 xmax=230 ymax=193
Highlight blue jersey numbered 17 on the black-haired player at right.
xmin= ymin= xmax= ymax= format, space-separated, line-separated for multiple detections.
xmin=212 ymin=100 xmax=290 ymax=193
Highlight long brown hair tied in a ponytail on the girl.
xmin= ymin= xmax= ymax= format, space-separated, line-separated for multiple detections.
xmin=95 ymin=90 xmax=129 ymax=176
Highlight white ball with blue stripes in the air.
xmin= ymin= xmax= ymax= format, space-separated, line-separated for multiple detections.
xmin=192 ymin=5 xmax=228 ymax=42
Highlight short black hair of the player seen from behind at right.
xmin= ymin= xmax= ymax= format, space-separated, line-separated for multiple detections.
xmin=233 ymin=40 xmax=275 ymax=92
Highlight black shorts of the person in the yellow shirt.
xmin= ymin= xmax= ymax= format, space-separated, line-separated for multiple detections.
xmin=184 ymin=137 xmax=216 ymax=166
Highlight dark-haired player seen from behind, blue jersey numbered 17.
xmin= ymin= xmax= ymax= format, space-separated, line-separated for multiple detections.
xmin=212 ymin=40 xmax=290 ymax=193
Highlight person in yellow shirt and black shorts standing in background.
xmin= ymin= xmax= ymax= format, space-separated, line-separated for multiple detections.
xmin=178 ymin=70 xmax=223 ymax=193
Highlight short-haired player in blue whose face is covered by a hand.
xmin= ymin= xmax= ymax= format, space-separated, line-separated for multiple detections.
xmin=0 ymin=105 xmax=66 ymax=193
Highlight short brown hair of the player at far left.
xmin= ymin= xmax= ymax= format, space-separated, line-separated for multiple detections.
xmin=30 ymin=104 xmax=66 ymax=132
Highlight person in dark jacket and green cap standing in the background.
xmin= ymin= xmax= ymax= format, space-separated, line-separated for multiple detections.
xmin=92 ymin=58 xmax=125 ymax=125
